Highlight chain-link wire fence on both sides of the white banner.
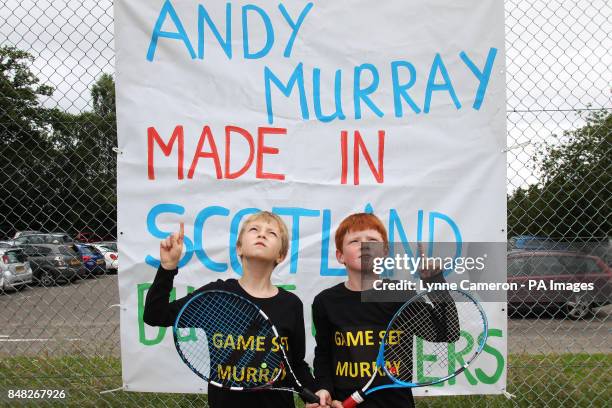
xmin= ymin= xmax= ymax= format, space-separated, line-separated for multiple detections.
xmin=0 ymin=0 xmax=612 ymax=407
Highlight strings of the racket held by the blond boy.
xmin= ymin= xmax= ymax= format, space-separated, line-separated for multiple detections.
xmin=177 ymin=292 xmax=282 ymax=388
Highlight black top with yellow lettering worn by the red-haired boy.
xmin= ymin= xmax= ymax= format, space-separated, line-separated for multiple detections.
xmin=312 ymin=275 xmax=456 ymax=408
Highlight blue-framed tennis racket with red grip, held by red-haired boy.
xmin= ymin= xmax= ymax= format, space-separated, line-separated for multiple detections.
xmin=342 ymin=290 xmax=488 ymax=408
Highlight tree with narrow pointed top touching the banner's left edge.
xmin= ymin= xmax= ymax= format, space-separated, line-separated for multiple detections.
xmin=47 ymin=74 xmax=117 ymax=237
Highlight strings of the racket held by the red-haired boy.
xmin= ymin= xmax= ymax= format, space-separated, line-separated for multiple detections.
xmin=384 ymin=291 xmax=485 ymax=383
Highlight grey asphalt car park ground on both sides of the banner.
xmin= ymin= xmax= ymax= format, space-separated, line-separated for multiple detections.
xmin=0 ymin=275 xmax=612 ymax=357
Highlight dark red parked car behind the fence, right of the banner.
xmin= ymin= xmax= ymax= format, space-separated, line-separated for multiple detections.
xmin=508 ymin=251 xmax=612 ymax=319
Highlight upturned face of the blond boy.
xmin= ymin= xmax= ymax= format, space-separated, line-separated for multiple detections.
xmin=236 ymin=220 xmax=282 ymax=263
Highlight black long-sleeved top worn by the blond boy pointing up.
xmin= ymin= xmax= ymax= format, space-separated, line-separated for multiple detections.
xmin=143 ymin=267 xmax=315 ymax=408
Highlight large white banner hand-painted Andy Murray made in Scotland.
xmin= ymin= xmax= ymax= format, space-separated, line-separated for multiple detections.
xmin=115 ymin=0 xmax=507 ymax=395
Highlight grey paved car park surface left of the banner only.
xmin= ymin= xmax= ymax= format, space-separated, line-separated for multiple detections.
xmin=0 ymin=275 xmax=120 ymax=356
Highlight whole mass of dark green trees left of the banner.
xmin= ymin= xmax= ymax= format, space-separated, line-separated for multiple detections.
xmin=0 ymin=47 xmax=117 ymax=238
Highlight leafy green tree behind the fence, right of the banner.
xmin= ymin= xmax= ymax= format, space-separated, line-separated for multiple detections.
xmin=508 ymin=110 xmax=612 ymax=240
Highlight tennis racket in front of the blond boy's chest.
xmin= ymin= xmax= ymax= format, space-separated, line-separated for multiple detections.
xmin=173 ymin=290 xmax=319 ymax=402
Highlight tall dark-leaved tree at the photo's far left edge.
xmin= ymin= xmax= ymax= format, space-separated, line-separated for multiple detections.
xmin=0 ymin=46 xmax=54 ymax=239
